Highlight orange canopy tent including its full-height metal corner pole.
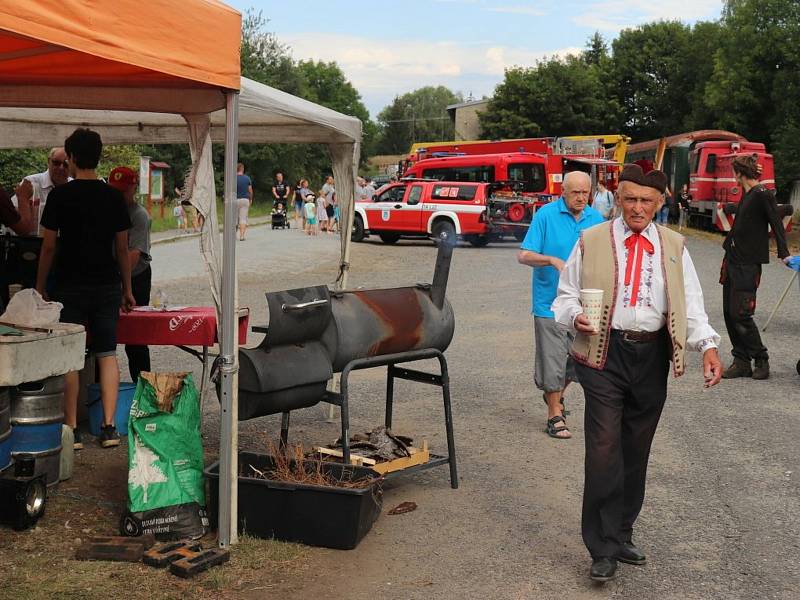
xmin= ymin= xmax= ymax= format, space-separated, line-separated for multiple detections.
xmin=0 ymin=0 xmax=241 ymax=545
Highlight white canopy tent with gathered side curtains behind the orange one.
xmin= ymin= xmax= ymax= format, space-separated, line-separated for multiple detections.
xmin=0 ymin=78 xmax=361 ymax=292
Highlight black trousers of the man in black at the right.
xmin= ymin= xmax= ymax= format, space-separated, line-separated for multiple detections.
xmin=720 ymin=259 xmax=769 ymax=362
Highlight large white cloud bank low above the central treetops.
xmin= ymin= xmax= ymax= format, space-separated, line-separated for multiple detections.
xmin=284 ymin=32 xmax=581 ymax=115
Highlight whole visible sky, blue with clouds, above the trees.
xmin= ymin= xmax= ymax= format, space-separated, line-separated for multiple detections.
xmin=225 ymin=0 xmax=722 ymax=116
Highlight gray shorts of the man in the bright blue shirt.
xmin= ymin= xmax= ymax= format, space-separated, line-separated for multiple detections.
xmin=533 ymin=317 xmax=578 ymax=392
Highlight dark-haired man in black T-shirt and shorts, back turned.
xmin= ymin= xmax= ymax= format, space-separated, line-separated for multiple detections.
xmin=36 ymin=129 xmax=136 ymax=449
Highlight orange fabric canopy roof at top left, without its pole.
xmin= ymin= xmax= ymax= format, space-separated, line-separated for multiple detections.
xmin=0 ymin=0 xmax=241 ymax=113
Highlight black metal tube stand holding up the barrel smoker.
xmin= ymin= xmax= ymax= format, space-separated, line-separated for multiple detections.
xmin=318 ymin=348 xmax=458 ymax=489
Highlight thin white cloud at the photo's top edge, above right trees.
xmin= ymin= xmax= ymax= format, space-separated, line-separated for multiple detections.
xmin=572 ymin=0 xmax=722 ymax=31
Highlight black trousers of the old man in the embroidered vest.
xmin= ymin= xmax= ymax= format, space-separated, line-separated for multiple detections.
xmin=576 ymin=332 xmax=669 ymax=558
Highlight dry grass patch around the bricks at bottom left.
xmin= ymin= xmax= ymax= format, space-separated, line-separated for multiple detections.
xmin=0 ymin=494 xmax=308 ymax=600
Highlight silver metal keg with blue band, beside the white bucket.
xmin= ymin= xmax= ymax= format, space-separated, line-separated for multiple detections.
xmin=10 ymin=375 xmax=64 ymax=487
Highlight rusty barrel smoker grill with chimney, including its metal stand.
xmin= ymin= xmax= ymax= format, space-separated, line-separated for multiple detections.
xmin=239 ymin=241 xmax=458 ymax=488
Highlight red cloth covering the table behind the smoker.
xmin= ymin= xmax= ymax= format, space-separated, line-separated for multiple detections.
xmin=117 ymin=306 xmax=250 ymax=346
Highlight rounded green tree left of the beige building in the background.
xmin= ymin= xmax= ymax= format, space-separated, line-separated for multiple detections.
xmin=377 ymin=85 xmax=463 ymax=154
